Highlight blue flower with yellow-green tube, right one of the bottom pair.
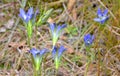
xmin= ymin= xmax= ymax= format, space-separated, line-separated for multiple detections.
xmin=52 ymin=46 xmax=66 ymax=69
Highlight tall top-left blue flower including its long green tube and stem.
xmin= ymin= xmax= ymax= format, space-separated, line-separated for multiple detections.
xmin=19 ymin=7 xmax=35 ymax=48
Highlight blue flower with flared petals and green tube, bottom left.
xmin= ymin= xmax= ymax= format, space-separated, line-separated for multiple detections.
xmin=30 ymin=48 xmax=48 ymax=71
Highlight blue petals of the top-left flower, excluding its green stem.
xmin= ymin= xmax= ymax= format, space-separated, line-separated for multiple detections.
xmin=19 ymin=7 xmax=34 ymax=23
